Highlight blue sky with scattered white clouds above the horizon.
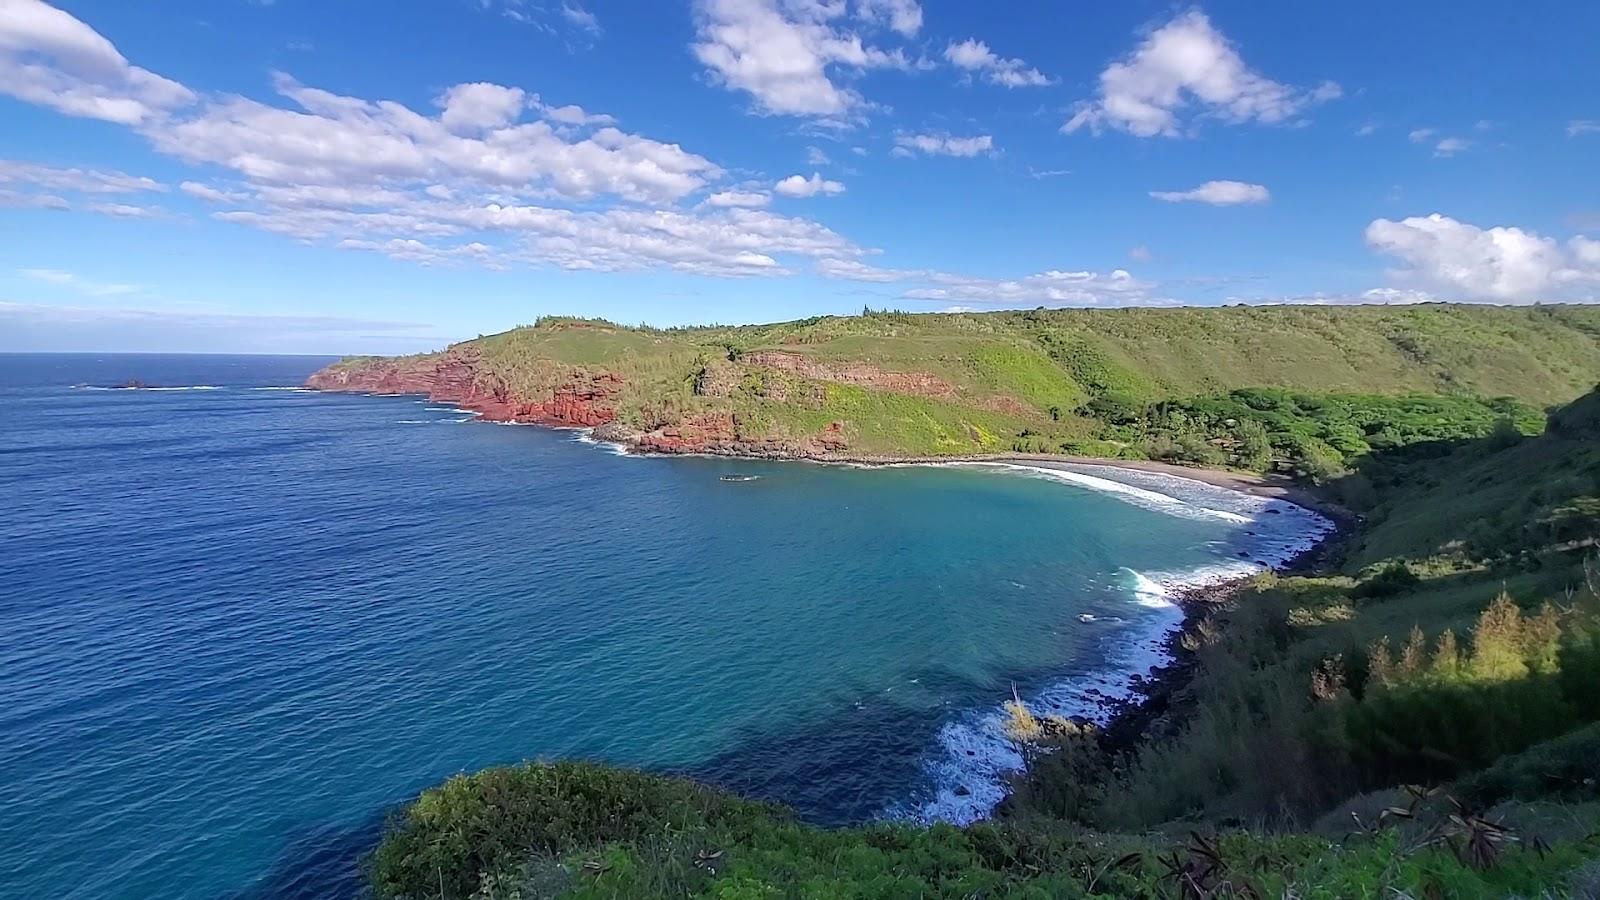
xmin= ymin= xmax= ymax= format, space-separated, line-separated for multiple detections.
xmin=0 ymin=0 xmax=1600 ymax=354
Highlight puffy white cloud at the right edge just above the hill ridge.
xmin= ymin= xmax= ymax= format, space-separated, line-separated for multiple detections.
xmin=1366 ymin=213 xmax=1600 ymax=303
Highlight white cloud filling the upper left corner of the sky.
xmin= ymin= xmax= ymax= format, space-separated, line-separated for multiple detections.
xmin=0 ymin=0 xmax=195 ymax=125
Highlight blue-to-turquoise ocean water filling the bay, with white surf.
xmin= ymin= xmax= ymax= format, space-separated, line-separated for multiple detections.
xmin=0 ymin=354 xmax=1318 ymax=900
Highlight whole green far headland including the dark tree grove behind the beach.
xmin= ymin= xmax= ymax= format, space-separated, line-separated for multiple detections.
xmin=352 ymin=304 xmax=1600 ymax=464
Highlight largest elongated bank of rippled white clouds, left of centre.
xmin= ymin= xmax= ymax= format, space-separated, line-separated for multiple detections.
xmin=0 ymin=0 xmax=906 ymax=277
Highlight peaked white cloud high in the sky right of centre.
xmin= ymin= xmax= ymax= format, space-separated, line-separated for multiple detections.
xmin=1061 ymin=10 xmax=1342 ymax=138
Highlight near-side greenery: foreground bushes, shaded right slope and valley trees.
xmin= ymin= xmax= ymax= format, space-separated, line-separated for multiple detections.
xmin=371 ymin=391 xmax=1600 ymax=900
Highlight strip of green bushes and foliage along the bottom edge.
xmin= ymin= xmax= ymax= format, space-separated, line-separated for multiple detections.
xmin=373 ymin=762 xmax=1600 ymax=900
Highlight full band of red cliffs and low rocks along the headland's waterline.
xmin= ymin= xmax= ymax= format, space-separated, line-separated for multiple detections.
xmin=306 ymin=348 xmax=850 ymax=460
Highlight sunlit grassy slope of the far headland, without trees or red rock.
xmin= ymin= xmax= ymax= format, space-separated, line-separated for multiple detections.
xmin=406 ymin=306 xmax=1600 ymax=456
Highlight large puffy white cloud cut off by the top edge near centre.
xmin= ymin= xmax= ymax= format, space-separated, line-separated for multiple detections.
xmin=691 ymin=0 xmax=920 ymax=123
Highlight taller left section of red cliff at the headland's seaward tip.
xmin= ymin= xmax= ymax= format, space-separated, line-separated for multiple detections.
xmin=306 ymin=349 xmax=622 ymax=428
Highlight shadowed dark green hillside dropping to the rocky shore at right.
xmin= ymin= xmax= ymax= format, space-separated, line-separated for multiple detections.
xmin=1016 ymin=391 xmax=1600 ymax=830
